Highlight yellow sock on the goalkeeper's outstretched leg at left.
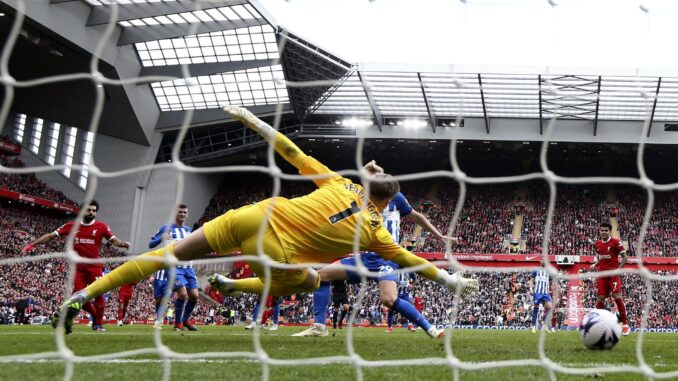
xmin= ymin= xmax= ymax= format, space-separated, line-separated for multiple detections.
xmin=84 ymin=245 xmax=174 ymax=299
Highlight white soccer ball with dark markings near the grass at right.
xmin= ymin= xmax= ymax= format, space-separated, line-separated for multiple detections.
xmin=579 ymin=310 xmax=621 ymax=349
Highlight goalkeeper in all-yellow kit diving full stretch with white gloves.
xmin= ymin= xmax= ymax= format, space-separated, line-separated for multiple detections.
xmin=56 ymin=106 xmax=478 ymax=331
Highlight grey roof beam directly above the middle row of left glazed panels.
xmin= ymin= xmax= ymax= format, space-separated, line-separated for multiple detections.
xmin=118 ymin=18 xmax=268 ymax=45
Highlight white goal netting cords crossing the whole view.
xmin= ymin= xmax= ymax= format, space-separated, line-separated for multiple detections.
xmin=0 ymin=1 xmax=678 ymax=380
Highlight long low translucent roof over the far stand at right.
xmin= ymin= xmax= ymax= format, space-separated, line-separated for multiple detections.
xmin=313 ymin=69 xmax=678 ymax=121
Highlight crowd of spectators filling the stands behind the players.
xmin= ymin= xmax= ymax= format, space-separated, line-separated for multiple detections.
xmin=0 ymin=170 xmax=678 ymax=327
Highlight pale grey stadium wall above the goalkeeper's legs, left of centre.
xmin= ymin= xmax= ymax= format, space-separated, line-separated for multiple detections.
xmin=94 ymin=132 xmax=221 ymax=253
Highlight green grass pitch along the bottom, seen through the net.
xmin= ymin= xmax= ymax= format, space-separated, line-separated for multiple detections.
xmin=0 ymin=326 xmax=678 ymax=381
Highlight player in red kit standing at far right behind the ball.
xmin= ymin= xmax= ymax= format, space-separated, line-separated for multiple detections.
xmin=591 ymin=222 xmax=631 ymax=336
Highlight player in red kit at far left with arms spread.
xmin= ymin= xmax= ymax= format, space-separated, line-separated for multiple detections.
xmin=21 ymin=200 xmax=130 ymax=333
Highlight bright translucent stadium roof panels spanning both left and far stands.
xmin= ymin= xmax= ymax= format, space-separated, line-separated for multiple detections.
xmin=63 ymin=0 xmax=678 ymax=123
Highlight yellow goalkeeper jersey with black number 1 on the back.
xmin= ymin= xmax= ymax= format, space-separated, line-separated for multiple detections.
xmin=269 ymin=156 xmax=405 ymax=263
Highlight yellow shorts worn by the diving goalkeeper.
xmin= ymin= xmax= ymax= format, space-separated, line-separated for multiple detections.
xmin=203 ymin=198 xmax=308 ymax=287
